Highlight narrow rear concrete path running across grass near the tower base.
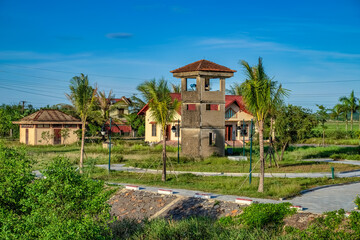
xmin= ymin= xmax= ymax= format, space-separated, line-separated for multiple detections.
xmin=96 ymin=164 xmax=360 ymax=178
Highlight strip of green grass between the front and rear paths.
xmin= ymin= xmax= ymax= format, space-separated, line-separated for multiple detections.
xmin=92 ymin=169 xmax=360 ymax=199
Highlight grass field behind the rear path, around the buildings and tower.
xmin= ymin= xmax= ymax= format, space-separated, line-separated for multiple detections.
xmin=6 ymin=141 xmax=360 ymax=173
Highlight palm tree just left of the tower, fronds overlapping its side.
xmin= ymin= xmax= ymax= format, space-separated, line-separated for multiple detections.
xmin=137 ymin=79 xmax=180 ymax=182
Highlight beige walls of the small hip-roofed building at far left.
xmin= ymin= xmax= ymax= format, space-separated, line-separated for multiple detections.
xmin=20 ymin=126 xmax=79 ymax=145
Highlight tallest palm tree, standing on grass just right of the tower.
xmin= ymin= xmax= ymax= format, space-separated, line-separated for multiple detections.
xmin=241 ymin=57 xmax=287 ymax=192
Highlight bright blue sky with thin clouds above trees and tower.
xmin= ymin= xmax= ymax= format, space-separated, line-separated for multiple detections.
xmin=0 ymin=0 xmax=360 ymax=109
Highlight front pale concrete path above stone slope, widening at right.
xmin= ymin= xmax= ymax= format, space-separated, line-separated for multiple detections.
xmin=109 ymin=183 xmax=360 ymax=213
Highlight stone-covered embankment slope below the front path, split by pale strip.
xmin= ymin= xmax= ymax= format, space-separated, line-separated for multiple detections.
xmin=109 ymin=189 xmax=241 ymax=221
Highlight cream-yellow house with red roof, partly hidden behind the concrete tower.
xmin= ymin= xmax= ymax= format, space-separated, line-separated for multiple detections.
xmin=138 ymin=93 xmax=254 ymax=143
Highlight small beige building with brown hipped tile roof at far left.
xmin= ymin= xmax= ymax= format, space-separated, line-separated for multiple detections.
xmin=13 ymin=109 xmax=81 ymax=145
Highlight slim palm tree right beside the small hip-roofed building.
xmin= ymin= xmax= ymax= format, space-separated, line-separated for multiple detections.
xmin=66 ymin=73 xmax=96 ymax=173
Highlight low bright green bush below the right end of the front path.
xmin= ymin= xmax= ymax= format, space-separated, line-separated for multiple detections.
xmin=239 ymin=203 xmax=296 ymax=228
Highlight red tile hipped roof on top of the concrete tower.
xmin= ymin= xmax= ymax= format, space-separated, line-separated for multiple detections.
xmin=170 ymin=59 xmax=236 ymax=73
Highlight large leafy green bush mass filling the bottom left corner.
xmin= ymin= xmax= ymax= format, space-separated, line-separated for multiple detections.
xmin=0 ymin=145 xmax=111 ymax=239
